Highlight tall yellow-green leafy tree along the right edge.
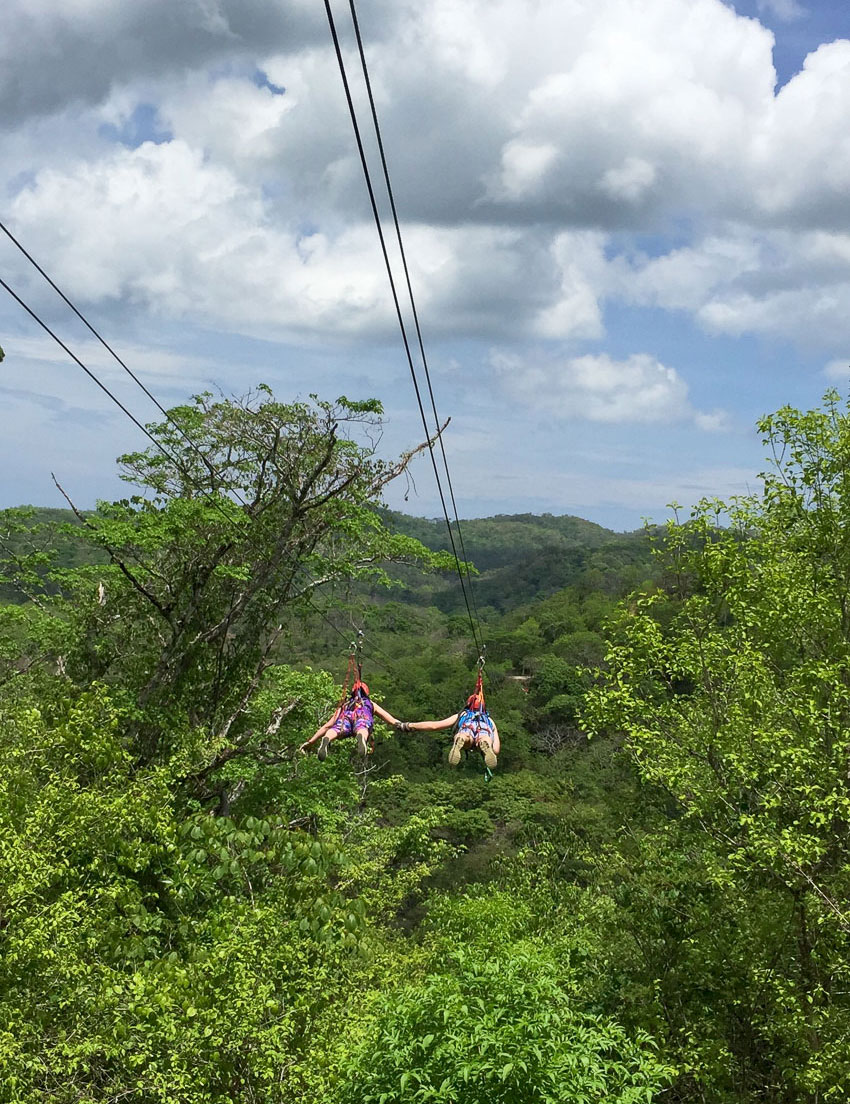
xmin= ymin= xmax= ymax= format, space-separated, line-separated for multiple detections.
xmin=587 ymin=392 xmax=850 ymax=1101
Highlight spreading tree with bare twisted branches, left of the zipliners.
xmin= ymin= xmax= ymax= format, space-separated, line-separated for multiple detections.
xmin=0 ymin=388 xmax=447 ymax=757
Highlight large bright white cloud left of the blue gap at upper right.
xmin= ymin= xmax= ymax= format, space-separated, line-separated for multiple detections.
xmin=489 ymin=0 xmax=774 ymax=226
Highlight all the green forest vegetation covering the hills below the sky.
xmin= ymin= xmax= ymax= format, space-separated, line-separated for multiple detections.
xmin=0 ymin=388 xmax=850 ymax=1104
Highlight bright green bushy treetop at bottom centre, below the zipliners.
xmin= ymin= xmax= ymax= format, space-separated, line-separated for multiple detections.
xmin=339 ymin=893 xmax=670 ymax=1104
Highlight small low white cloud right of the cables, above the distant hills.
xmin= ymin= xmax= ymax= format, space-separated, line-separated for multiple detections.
xmin=491 ymin=352 xmax=726 ymax=432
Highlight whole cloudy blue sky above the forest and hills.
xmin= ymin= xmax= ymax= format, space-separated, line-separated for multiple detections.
xmin=0 ymin=0 xmax=850 ymax=530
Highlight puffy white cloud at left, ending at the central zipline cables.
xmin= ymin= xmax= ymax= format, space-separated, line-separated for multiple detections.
xmin=4 ymin=139 xmax=389 ymax=332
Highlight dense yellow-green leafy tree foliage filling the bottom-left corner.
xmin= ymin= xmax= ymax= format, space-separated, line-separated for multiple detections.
xmin=0 ymin=677 xmax=377 ymax=1104
